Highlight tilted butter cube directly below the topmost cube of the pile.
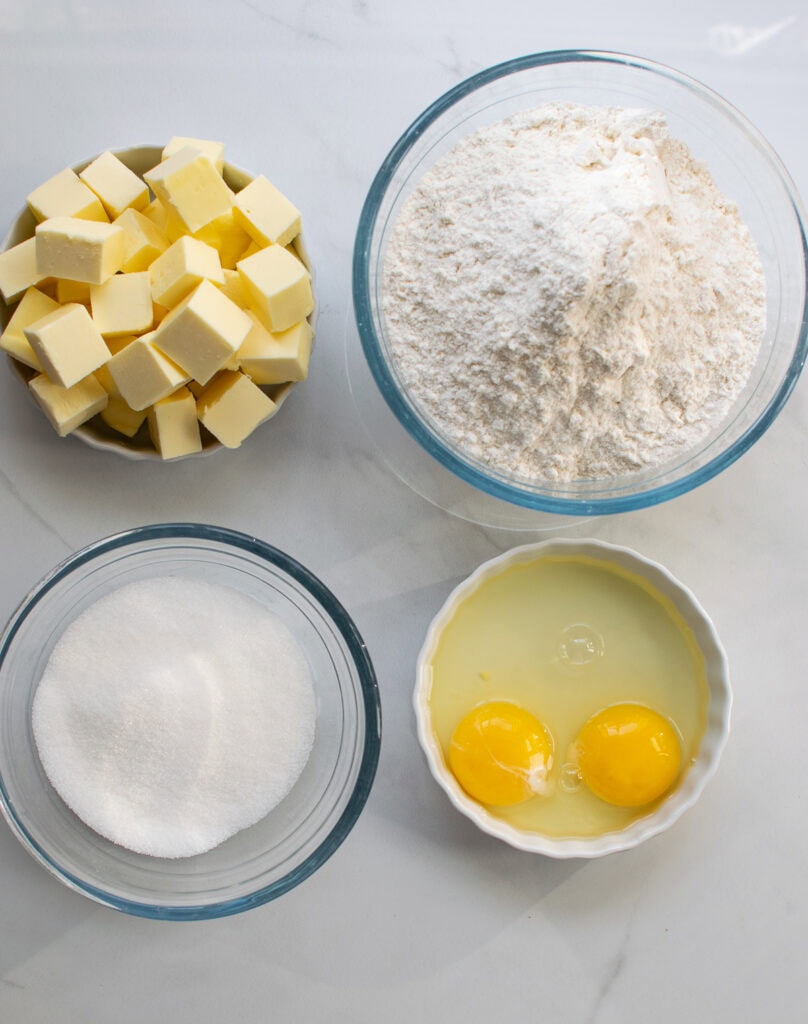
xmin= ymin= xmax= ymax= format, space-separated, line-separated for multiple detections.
xmin=143 ymin=146 xmax=232 ymax=234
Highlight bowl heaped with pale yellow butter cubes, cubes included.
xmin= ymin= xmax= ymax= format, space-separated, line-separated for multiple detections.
xmin=0 ymin=136 xmax=316 ymax=460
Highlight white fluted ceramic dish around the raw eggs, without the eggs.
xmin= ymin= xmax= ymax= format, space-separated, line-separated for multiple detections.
xmin=414 ymin=539 xmax=732 ymax=859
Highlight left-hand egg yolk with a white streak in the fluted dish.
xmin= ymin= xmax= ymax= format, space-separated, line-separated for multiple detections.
xmin=449 ymin=700 xmax=553 ymax=807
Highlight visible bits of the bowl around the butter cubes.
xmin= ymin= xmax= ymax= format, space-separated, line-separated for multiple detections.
xmin=0 ymin=145 xmax=318 ymax=462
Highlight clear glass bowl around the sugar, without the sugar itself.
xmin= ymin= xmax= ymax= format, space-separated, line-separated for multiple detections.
xmin=0 ymin=523 xmax=381 ymax=921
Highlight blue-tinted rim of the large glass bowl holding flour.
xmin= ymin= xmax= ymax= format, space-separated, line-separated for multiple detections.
xmin=353 ymin=50 xmax=808 ymax=515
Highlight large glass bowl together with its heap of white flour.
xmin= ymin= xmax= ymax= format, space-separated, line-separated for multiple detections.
xmin=353 ymin=51 xmax=808 ymax=515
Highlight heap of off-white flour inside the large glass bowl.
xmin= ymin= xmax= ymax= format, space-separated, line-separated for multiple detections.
xmin=383 ymin=104 xmax=765 ymax=481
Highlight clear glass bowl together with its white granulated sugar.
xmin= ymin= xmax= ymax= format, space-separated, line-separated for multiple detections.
xmin=0 ymin=523 xmax=381 ymax=921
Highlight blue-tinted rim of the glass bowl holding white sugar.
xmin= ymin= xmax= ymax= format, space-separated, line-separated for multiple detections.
xmin=0 ymin=522 xmax=381 ymax=921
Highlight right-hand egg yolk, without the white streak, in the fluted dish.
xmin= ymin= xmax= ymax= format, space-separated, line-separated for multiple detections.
xmin=576 ymin=703 xmax=682 ymax=807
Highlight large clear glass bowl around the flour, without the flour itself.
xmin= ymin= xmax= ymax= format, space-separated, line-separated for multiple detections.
xmin=353 ymin=50 xmax=808 ymax=515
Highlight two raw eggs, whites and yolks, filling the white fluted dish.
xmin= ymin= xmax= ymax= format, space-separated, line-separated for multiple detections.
xmin=426 ymin=555 xmax=708 ymax=836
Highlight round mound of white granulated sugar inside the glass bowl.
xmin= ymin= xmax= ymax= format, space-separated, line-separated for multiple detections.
xmin=33 ymin=577 xmax=315 ymax=857
